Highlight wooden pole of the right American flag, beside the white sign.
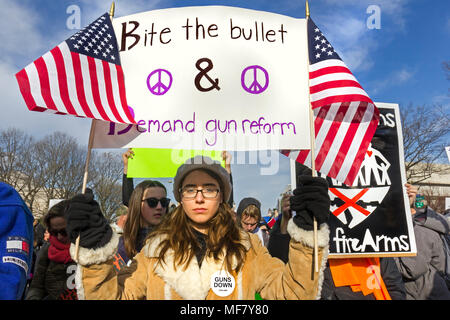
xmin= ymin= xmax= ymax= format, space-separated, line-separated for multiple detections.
xmin=305 ymin=0 xmax=319 ymax=272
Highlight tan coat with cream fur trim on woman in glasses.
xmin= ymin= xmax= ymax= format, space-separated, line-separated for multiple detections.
xmin=71 ymin=219 xmax=329 ymax=300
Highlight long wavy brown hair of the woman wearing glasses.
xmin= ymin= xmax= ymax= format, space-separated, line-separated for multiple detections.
xmin=149 ymin=202 xmax=246 ymax=272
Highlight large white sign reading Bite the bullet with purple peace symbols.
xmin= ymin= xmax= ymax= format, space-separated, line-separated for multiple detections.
xmin=93 ymin=6 xmax=310 ymax=151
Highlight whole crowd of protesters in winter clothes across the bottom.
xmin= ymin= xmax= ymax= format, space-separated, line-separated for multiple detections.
xmin=0 ymin=150 xmax=450 ymax=300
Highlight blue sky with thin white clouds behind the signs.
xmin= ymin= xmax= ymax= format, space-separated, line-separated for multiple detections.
xmin=0 ymin=0 xmax=450 ymax=215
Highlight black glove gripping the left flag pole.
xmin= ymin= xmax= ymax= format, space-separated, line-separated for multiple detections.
xmin=66 ymin=193 xmax=112 ymax=249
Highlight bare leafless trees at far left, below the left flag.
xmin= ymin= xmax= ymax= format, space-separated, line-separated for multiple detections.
xmin=0 ymin=128 xmax=123 ymax=221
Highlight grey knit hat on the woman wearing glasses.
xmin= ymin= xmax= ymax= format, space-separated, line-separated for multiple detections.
xmin=173 ymin=155 xmax=231 ymax=202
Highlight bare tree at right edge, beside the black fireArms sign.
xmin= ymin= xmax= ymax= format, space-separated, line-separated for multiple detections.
xmin=401 ymin=105 xmax=450 ymax=184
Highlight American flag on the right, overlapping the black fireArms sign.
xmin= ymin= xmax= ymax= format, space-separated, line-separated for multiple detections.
xmin=281 ymin=18 xmax=379 ymax=186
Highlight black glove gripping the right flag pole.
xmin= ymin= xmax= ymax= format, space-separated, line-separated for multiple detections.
xmin=290 ymin=176 xmax=330 ymax=230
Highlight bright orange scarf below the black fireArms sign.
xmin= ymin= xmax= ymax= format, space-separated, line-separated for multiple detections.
xmin=328 ymin=258 xmax=391 ymax=300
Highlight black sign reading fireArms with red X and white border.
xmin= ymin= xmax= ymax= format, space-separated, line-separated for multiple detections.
xmin=296 ymin=103 xmax=417 ymax=258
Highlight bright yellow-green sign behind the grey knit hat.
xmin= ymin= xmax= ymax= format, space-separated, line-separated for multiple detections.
xmin=127 ymin=148 xmax=224 ymax=178
